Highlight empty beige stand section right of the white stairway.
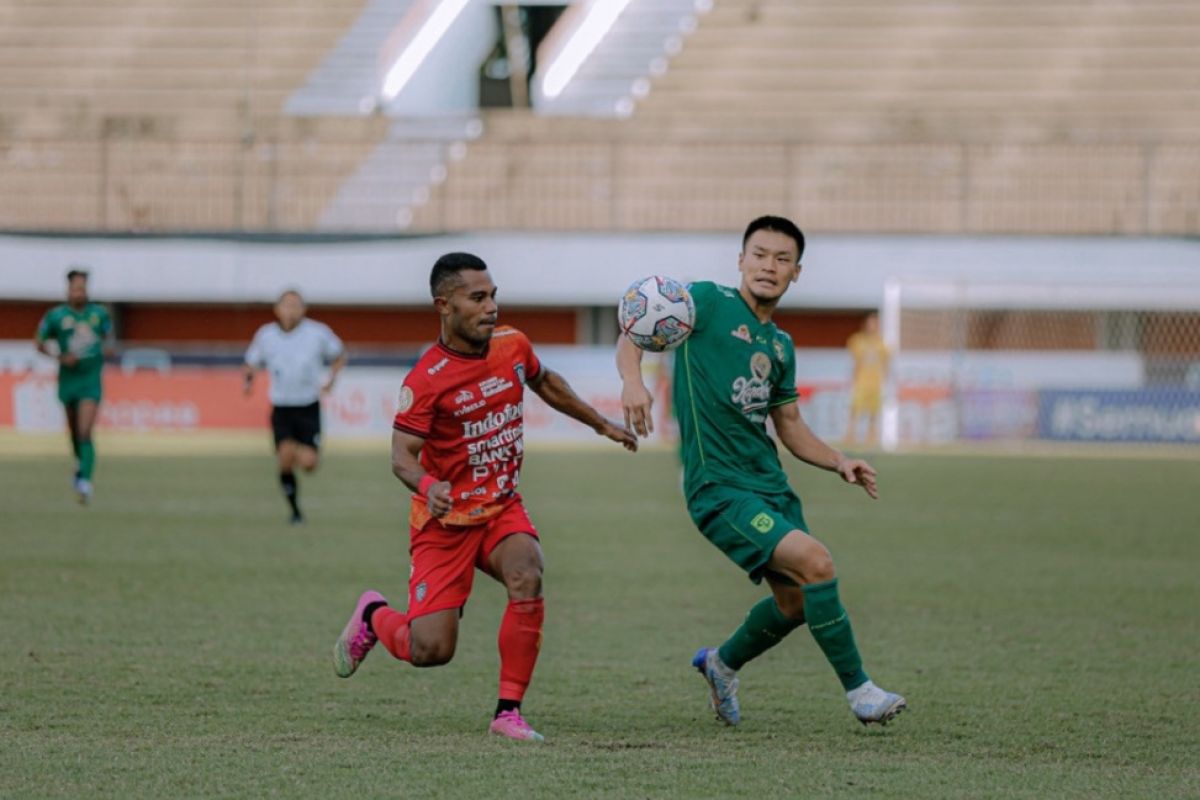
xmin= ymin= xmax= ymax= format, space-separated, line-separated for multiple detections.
xmin=413 ymin=0 xmax=1200 ymax=234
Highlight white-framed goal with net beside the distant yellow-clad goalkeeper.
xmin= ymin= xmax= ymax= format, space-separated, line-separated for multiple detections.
xmin=881 ymin=281 xmax=1200 ymax=457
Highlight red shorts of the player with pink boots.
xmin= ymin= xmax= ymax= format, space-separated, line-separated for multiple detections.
xmin=408 ymin=500 xmax=538 ymax=619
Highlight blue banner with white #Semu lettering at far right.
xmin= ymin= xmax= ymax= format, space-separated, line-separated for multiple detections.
xmin=1038 ymin=389 xmax=1200 ymax=444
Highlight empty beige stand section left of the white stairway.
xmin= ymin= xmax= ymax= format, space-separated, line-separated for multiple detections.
xmin=0 ymin=0 xmax=386 ymax=230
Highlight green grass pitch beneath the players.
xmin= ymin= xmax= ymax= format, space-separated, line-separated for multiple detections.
xmin=0 ymin=443 xmax=1200 ymax=800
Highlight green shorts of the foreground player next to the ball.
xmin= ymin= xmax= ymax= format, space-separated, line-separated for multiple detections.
xmin=688 ymin=485 xmax=809 ymax=583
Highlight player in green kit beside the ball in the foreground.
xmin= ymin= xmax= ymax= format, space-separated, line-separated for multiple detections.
xmin=617 ymin=217 xmax=906 ymax=724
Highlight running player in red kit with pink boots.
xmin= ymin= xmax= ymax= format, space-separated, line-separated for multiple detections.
xmin=334 ymin=253 xmax=637 ymax=741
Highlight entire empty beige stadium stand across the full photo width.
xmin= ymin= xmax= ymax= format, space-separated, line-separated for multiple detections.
xmin=0 ymin=0 xmax=1200 ymax=234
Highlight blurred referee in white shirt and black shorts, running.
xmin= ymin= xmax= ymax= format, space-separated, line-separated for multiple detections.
xmin=244 ymin=289 xmax=346 ymax=524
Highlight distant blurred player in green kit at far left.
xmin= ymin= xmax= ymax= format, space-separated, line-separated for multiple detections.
xmin=35 ymin=269 xmax=113 ymax=503
